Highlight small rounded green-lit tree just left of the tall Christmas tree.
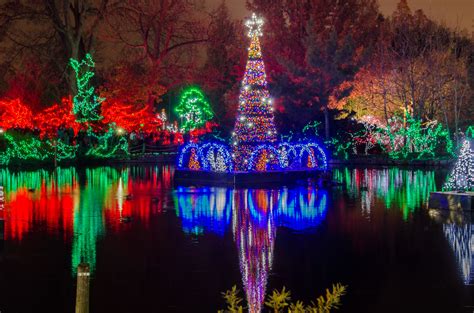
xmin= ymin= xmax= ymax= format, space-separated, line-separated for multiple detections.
xmin=175 ymin=87 xmax=214 ymax=132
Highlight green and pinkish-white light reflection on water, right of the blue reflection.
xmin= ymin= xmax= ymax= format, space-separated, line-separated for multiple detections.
xmin=334 ymin=168 xmax=436 ymax=220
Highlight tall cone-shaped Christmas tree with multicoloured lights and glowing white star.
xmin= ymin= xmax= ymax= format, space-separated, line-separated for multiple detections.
xmin=232 ymin=13 xmax=277 ymax=170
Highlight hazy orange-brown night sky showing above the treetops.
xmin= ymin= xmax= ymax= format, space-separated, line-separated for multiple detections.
xmin=206 ymin=0 xmax=474 ymax=32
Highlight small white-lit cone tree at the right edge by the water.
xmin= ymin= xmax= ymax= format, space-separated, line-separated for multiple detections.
xmin=443 ymin=139 xmax=474 ymax=191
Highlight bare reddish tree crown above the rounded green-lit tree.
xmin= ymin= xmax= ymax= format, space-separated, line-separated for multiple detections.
xmin=107 ymin=0 xmax=208 ymax=87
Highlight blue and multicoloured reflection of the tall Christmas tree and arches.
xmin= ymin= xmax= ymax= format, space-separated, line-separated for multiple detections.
xmin=176 ymin=186 xmax=327 ymax=312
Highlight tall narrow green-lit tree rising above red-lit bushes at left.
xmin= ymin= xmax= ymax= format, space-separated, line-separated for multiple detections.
xmin=69 ymin=53 xmax=104 ymax=123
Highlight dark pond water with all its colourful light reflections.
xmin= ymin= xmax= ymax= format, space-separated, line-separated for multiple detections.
xmin=0 ymin=166 xmax=474 ymax=313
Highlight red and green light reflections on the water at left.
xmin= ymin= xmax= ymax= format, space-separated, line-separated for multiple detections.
xmin=0 ymin=167 xmax=172 ymax=275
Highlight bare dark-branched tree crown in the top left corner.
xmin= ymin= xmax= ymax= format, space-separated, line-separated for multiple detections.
xmin=0 ymin=0 xmax=109 ymax=93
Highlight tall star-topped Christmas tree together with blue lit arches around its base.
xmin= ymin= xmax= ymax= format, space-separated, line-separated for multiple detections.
xmin=178 ymin=14 xmax=327 ymax=173
